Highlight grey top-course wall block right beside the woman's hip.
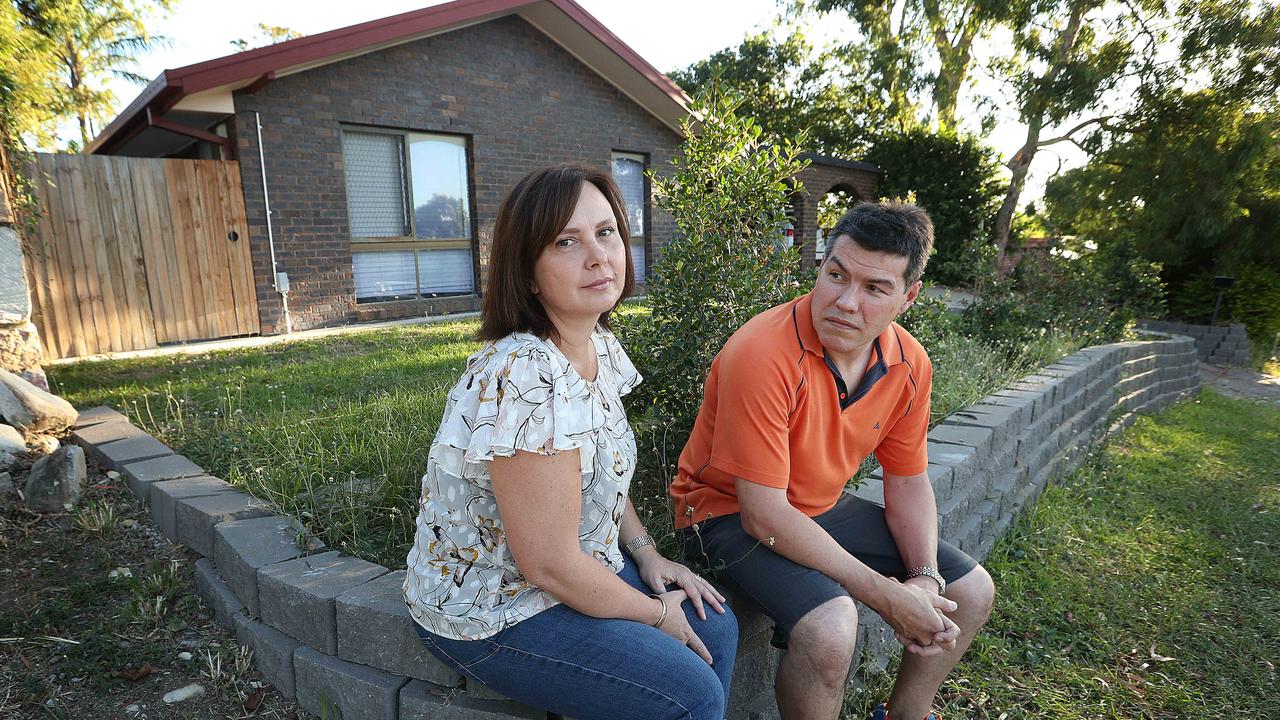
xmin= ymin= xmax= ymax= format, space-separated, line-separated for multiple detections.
xmin=333 ymin=570 xmax=462 ymax=685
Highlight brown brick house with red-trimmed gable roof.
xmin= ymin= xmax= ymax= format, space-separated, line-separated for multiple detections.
xmin=86 ymin=0 xmax=689 ymax=334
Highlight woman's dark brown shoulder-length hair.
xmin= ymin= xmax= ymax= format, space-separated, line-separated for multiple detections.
xmin=479 ymin=164 xmax=635 ymax=340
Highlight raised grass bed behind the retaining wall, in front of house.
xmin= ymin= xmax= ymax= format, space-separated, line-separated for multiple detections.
xmin=51 ymin=306 xmax=1090 ymax=568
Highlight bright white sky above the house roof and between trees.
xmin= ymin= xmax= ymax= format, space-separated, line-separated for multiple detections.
xmin=87 ymin=0 xmax=1084 ymax=202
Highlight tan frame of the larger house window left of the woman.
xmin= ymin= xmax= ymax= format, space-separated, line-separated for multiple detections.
xmin=338 ymin=123 xmax=480 ymax=299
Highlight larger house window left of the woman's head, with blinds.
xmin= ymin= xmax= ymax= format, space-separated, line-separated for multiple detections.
xmin=342 ymin=129 xmax=475 ymax=302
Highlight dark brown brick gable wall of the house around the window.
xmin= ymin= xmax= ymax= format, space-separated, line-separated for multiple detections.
xmin=234 ymin=17 xmax=680 ymax=333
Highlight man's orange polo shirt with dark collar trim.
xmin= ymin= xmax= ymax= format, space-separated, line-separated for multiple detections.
xmin=671 ymin=289 xmax=933 ymax=528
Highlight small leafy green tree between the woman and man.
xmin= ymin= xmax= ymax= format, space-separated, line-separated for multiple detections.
xmin=632 ymin=91 xmax=806 ymax=452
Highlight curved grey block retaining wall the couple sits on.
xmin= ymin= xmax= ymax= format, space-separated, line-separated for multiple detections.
xmin=73 ymin=337 xmax=1199 ymax=720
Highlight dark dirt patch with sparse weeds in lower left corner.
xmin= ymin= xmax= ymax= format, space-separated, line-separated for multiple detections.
xmin=0 ymin=456 xmax=302 ymax=720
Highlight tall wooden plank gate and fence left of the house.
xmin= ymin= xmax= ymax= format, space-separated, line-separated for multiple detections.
xmin=27 ymin=154 xmax=260 ymax=357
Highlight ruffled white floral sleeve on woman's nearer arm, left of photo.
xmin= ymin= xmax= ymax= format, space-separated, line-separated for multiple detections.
xmin=433 ymin=341 xmax=595 ymax=487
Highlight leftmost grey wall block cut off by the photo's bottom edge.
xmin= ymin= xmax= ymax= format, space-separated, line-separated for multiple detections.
xmin=293 ymin=644 xmax=408 ymax=720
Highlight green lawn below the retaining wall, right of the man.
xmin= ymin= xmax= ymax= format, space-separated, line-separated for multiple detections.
xmin=846 ymin=392 xmax=1280 ymax=720
